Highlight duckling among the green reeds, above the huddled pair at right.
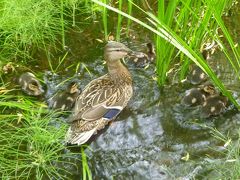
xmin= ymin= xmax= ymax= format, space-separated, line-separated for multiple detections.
xmin=187 ymin=64 xmax=207 ymax=85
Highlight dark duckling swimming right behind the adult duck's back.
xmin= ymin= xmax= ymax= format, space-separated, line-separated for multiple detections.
xmin=49 ymin=82 xmax=81 ymax=111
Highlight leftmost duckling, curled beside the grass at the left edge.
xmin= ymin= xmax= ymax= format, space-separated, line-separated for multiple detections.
xmin=18 ymin=72 xmax=44 ymax=96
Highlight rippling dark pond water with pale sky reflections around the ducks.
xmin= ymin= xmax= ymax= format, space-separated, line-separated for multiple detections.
xmin=3 ymin=1 xmax=240 ymax=180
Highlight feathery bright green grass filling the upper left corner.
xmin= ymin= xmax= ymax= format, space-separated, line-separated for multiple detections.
xmin=0 ymin=0 xmax=93 ymax=64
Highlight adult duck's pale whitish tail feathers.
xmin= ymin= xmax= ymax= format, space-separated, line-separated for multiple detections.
xmin=65 ymin=127 xmax=97 ymax=145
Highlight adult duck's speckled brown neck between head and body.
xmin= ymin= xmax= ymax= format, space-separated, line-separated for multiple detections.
xmin=107 ymin=60 xmax=132 ymax=84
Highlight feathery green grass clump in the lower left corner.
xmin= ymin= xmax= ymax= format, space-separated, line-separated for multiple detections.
xmin=0 ymin=91 xmax=91 ymax=179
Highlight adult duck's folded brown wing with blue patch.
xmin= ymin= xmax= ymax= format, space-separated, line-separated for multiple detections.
xmin=68 ymin=75 xmax=132 ymax=122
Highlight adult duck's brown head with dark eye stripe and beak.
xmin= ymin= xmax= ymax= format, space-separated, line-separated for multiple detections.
xmin=104 ymin=41 xmax=132 ymax=62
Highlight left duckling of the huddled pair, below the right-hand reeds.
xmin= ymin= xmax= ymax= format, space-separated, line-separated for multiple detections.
xmin=182 ymin=82 xmax=216 ymax=106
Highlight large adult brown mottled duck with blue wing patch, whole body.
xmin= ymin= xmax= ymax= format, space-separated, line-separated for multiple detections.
xmin=65 ymin=41 xmax=133 ymax=145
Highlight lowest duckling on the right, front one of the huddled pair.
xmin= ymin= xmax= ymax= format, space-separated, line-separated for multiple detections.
xmin=202 ymin=94 xmax=228 ymax=118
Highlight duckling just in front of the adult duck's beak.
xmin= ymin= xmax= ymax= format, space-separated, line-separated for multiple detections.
xmin=133 ymin=42 xmax=156 ymax=68
